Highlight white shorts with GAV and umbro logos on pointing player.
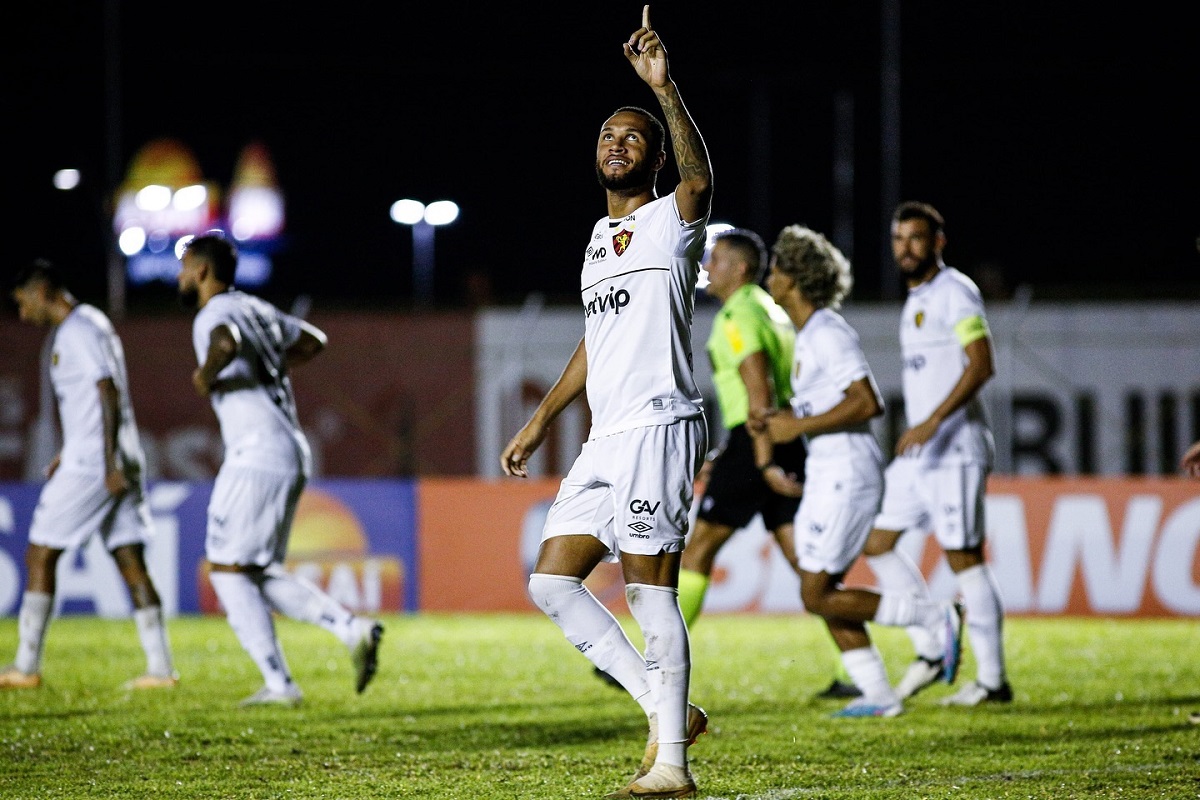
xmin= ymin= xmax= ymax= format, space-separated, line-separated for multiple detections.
xmin=541 ymin=417 xmax=708 ymax=561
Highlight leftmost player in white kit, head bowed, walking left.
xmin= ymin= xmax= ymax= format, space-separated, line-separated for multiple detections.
xmin=0 ymin=259 xmax=179 ymax=688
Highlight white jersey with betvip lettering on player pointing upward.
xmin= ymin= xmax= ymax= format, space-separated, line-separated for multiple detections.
xmin=580 ymin=194 xmax=707 ymax=439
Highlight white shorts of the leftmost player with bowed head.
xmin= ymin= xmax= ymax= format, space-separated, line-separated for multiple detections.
xmin=29 ymin=469 xmax=151 ymax=552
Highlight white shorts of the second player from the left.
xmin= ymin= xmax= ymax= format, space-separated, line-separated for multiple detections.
xmin=204 ymin=463 xmax=307 ymax=567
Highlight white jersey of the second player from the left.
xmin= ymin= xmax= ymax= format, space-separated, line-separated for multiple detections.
xmin=192 ymin=289 xmax=311 ymax=474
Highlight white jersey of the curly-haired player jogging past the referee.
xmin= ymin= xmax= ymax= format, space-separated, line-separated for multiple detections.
xmin=792 ymin=308 xmax=883 ymax=479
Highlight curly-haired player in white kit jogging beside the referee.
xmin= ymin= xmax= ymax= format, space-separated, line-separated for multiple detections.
xmin=751 ymin=225 xmax=961 ymax=717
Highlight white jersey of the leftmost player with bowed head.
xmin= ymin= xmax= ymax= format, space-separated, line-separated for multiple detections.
xmin=50 ymin=303 xmax=145 ymax=483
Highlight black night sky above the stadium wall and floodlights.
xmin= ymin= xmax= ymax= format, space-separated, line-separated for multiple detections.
xmin=5 ymin=0 xmax=1200 ymax=307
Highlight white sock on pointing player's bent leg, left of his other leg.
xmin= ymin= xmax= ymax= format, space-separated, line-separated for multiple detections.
xmin=529 ymin=572 xmax=654 ymax=716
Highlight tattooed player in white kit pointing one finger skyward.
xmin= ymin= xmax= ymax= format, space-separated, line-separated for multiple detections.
xmin=500 ymin=6 xmax=713 ymax=798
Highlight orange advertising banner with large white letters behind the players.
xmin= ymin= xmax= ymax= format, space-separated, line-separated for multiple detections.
xmin=418 ymin=477 xmax=1200 ymax=616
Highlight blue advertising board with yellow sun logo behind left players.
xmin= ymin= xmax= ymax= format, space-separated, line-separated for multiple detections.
xmin=0 ymin=479 xmax=420 ymax=616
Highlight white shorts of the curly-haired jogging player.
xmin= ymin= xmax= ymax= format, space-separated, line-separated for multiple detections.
xmin=794 ymin=470 xmax=883 ymax=575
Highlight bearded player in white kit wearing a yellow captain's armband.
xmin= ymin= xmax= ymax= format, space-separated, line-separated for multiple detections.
xmin=864 ymin=201 xmax=1013 ymax=705
